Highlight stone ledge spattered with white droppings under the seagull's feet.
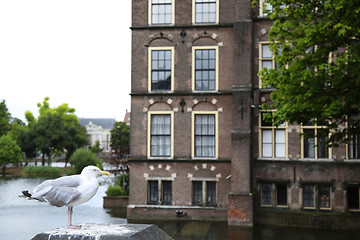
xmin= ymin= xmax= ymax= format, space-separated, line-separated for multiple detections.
xmin=32 ymin=224 xmax=172 ymax=240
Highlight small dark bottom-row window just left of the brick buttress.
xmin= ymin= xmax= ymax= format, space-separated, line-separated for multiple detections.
xmin=192 ymin=181 xmax=216 ymax=206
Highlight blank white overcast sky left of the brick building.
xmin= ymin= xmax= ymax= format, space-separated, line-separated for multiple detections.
xmin=0 ymin=0 xmax=131 ymax=121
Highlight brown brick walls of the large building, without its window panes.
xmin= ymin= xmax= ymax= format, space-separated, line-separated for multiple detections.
xmin=128 ymin=0 xmax=360 ymax=226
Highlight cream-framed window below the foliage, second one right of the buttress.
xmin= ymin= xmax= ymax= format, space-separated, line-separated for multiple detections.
xmin=301 ymin=124 xmax=331 ymax=159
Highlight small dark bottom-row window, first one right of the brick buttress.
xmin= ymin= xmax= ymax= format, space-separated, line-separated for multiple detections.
xmin=260 ymin=183 xmax=287 ymax=207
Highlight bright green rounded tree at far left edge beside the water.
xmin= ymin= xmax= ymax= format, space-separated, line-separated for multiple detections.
xmin=0 ymin=135 xmax=22 ymax=174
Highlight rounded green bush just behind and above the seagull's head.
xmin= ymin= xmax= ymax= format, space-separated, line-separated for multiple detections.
xmin=70 ymin=148 xmax=102 ymax=173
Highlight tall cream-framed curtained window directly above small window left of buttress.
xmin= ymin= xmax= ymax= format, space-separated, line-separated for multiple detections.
xmin=192 ymin=112 xmax=218 ymax=158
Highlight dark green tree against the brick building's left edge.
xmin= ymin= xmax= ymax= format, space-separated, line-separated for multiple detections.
xmin=110 ymin=122 xmax=130 ymax=158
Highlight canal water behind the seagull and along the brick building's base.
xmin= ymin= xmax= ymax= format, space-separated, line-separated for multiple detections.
xmin=0 ymin=177 xmax=360 ymax=240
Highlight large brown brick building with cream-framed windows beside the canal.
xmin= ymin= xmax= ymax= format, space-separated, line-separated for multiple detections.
xmin=127 ymin=0 xmax=360 ymax=229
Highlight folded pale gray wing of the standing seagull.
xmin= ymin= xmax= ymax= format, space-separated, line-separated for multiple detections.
xmin=31 ymin=175 xmax=81 ymax=207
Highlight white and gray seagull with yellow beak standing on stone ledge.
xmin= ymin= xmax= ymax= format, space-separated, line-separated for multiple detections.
xmin=20 ymin=166 xmax=110 ymax=229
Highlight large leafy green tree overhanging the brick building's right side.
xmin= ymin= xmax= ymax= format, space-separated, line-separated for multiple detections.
xmin=260 ymin=0 xmax=360 ymax=144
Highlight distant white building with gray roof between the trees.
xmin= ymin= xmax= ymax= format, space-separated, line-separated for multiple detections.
xmin=79 ymin=118 xmax=116 ymax=152
